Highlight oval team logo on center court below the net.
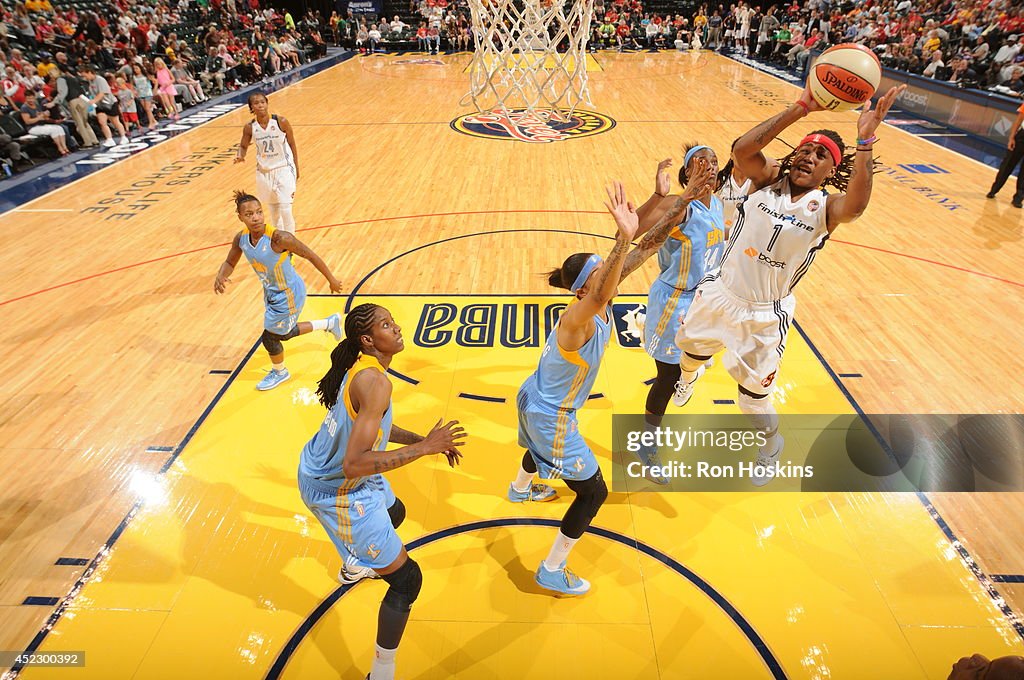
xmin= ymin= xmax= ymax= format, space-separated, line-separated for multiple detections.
xmin=452 ymin=109 xmax=615 ymax=143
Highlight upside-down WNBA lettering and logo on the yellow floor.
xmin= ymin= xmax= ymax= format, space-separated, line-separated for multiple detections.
xmin=409 ymin=296 xmax=645 ymax=348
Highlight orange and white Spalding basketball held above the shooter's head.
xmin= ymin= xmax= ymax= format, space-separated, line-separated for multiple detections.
xmin=807 ymin=43 xmax=882 ymax=111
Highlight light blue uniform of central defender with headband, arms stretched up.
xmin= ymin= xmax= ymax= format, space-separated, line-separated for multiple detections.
xmin=516 ymin=301 xmax=612 ymax=481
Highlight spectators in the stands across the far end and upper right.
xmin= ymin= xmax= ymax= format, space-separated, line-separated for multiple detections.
xmin=330 ymin=0 xmax=1024 ymax=96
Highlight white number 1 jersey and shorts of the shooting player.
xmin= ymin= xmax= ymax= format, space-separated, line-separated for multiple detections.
xmin=676 ymin=177 xmax=828 ymax=394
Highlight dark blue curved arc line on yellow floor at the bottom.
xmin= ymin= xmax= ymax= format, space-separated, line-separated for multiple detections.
xmin=265 ymin=517 xmax=786 ymax=680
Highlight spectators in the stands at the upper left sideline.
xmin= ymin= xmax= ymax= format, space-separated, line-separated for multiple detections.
xmin=0 ymin=0 xmax=327 ymax=178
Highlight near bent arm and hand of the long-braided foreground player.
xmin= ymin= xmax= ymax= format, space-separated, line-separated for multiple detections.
xmin=342 ymin=371 xmax=466 ymax=479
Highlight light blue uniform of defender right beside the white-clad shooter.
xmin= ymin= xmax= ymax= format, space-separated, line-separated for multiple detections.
xmin=644 ymin=196 xmax=725 ymax=364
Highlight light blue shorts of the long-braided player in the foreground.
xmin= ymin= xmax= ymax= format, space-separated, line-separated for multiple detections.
xmin=299 ymin=472 xmax=402 ymax=569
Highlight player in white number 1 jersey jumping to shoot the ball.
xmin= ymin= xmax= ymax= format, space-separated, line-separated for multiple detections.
xmin=673 ymin=86 xmax=905 ymax=485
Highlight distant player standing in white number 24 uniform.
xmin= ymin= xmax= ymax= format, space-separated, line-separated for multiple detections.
xmin=234 ymin=92 xmax=299 ymax=233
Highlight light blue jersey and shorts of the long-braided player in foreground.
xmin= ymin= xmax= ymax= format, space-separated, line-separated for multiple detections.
xmin=299 ymin=354 xmax=402 ymax=569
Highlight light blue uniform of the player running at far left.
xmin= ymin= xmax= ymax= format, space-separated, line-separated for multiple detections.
xmin=239 ymin=224 xmax=306 ymax=335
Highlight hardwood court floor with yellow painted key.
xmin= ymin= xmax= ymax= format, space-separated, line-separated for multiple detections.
xmin=0 ymin=53 xmax=1024 ymax=678
